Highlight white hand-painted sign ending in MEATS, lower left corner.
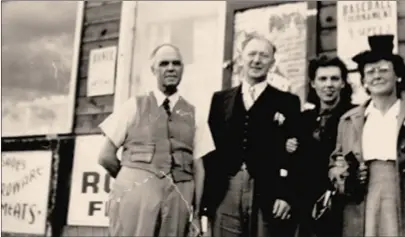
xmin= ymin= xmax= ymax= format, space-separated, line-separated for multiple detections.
xmin=1 ymin=151 xmax=52 ymax=235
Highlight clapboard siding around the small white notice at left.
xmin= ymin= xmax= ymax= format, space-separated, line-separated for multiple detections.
xmin=74 ymin=1 xmax=122 ymax=135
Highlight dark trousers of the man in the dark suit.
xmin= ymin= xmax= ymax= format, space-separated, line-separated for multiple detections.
xmin=212 ymin=166 xmax=295 ymax=237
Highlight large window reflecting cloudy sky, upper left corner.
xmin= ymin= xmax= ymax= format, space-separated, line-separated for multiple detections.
xmin=2 ymin=1 xmax=82 ymax=137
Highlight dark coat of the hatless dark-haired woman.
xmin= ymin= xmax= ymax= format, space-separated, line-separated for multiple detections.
xmin=296 ymin=101 xmax=354 ymax=236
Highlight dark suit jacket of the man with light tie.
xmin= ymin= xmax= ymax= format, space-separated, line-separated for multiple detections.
xmin=203 ymin=86 xmax=300 ymax=218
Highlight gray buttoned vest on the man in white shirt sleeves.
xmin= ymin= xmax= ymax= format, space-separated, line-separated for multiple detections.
xmin=121 ymin=93 xmax=195 ymax=182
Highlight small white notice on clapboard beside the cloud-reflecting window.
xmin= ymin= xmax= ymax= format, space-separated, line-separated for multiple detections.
xmin=87 ymin=46 xmax=117 ymax=96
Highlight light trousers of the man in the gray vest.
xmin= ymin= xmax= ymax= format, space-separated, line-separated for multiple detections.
xmin=108 ymin=167 xmax=194 ymax=237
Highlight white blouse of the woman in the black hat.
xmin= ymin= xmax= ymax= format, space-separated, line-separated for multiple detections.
xmin=362 ymin=100 xmax=400 ymax=160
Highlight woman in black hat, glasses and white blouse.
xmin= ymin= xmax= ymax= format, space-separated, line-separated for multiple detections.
xmin=329 ymin=35 xmax=405 ymax=236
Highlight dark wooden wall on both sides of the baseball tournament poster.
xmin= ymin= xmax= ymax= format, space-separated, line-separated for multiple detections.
xmin=318 ymin=1 xmax=405 ymax=58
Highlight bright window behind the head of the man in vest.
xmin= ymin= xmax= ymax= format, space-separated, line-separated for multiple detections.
xmin=130 ymin=1 xmax=226 ymax=114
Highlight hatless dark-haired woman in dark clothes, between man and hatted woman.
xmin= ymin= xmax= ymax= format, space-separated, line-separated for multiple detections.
xmin=287 ymin=56 xmax=354 ymax=237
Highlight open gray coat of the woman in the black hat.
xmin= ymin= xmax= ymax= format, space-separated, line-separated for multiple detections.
xmin=331 ymin=93 xmax=405 ymax=237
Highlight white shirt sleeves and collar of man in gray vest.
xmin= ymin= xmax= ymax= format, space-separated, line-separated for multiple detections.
xmin=99 ymin=90 xmax=215 ymax=159
